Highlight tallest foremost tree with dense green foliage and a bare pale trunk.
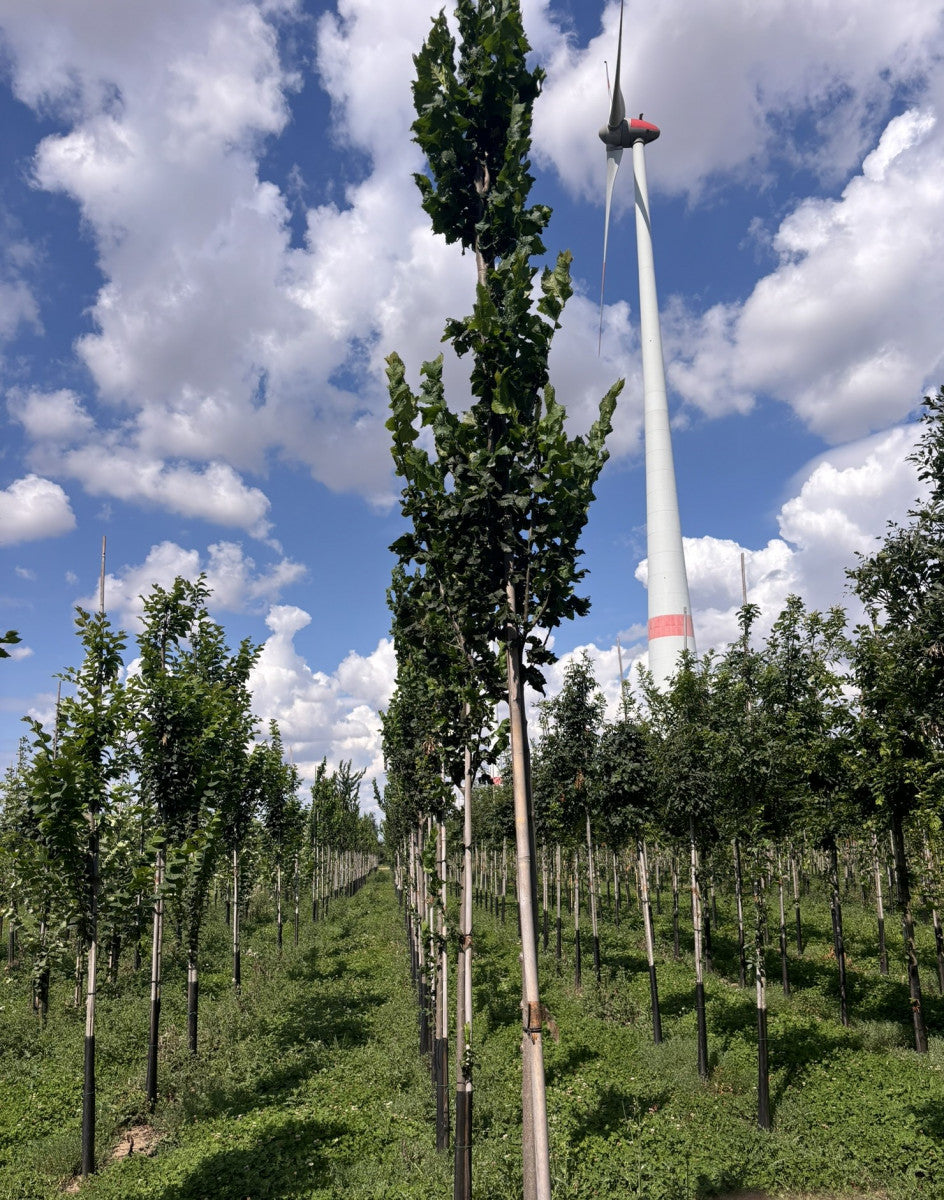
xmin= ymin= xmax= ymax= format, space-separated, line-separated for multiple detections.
xmin=387 ymin=0 xmax=619 ymax=1196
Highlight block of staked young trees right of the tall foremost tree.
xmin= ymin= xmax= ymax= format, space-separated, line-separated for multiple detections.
xmin=515 ymin=588 xmax=944 ymax=1089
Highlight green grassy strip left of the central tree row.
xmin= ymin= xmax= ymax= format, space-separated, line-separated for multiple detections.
xmin=0 ymin=881 xmax=449 ymax=1200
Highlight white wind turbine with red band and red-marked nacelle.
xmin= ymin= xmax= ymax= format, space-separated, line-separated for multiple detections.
xmin=600 ymin=0 xmax=695 ymax=688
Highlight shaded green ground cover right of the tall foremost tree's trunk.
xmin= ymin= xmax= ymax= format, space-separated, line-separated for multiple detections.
xmin=476 ymin=873 xmax=944 ymax=1200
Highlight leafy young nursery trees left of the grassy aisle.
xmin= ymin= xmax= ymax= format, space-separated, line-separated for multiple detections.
xmin=0 ymin=576 xmax=378 ymax=1174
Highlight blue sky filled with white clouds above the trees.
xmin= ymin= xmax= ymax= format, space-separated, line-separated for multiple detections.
xmin=0 ymin=0 xmax=944 ymax=806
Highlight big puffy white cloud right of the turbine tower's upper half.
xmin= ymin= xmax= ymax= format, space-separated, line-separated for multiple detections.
xmin=669 ymin=102 xmax=944 ymax=443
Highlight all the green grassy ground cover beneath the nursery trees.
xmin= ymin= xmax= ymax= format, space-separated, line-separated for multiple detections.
xmin=0 ymin=874 xmax=944 ymax=1200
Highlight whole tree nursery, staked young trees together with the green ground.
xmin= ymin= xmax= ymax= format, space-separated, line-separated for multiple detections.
xmin=0 ymin=0 xmax=944 ymax=1200
